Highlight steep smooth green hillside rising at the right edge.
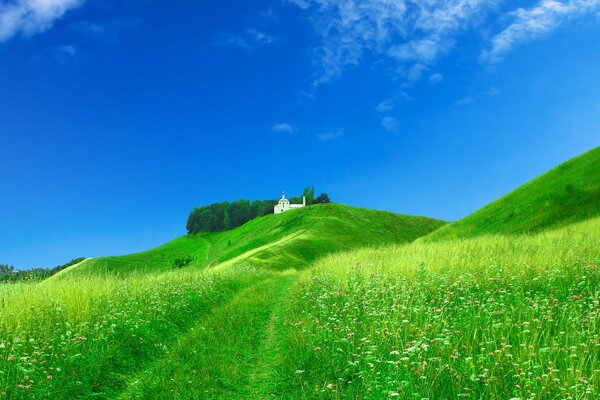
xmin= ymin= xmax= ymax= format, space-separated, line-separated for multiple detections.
xmin=423 ymin=147 xmax=600 ymax=241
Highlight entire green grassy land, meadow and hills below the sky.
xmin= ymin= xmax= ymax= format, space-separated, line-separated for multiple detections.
xmin=0 ymin=148 xmax=600 ymax=400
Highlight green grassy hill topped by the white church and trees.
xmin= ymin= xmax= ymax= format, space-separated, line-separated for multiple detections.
xmin=55 ymin=204 xmax=444 ymax=279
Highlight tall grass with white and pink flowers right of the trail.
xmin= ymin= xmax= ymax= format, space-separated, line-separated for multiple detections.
xmin=279 ymin=218 xmax=600 ymax=399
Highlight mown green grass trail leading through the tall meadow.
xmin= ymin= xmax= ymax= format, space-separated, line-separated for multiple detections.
xmin=119 ymin=272 xmax=297 ymax=400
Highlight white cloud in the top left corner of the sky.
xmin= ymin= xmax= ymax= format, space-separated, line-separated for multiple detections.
xmin=0 ymin=0 xmax=85 ymax=42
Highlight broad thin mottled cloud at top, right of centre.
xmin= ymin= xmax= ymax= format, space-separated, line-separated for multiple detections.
xmin=285 ymin=0 xmax=498 ymax=86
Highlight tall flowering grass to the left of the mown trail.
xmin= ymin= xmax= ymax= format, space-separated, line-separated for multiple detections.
xmin=0 ymin=268 xmax=270 ymax=399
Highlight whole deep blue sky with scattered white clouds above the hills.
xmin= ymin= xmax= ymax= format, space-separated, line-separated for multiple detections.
xmin=0 ymin=0 xmax=600 ymax=268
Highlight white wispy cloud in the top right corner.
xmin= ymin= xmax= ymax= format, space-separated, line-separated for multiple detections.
xmin=481 ymin=0 xmax=600 ymax=63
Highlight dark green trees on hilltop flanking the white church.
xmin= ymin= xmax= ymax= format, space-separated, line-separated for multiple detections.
xmin=186 ymin=187 xmax=331 ymax=235
